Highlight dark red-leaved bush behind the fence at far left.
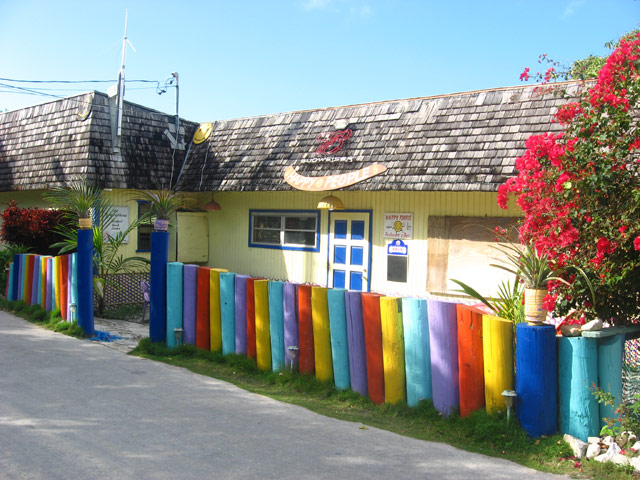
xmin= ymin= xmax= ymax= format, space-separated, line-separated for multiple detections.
xmin=0 ymin=200 xmax=69 ymax=255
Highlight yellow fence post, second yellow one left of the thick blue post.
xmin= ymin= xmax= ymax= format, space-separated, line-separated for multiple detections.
xmin=380 ymin=297 xmax=407 ymax=404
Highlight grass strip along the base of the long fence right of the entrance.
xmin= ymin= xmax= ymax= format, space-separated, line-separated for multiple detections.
xmin=131 ymin=338 xmax=637 ymax=480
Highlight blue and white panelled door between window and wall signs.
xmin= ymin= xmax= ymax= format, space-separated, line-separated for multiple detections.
xmin=328 ymin=212 xmax=371 ymax=292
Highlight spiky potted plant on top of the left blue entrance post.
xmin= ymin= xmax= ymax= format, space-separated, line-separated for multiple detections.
xmin=43 ymin=178 xmax=100 ymax=230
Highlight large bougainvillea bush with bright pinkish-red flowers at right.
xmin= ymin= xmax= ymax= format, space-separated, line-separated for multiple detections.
xmin=498 ymin=33 xmax=640 ymax=323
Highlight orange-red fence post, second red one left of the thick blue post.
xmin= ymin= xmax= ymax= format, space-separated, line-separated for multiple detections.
xmin=361 ymin=293 xmax=384 ymax=403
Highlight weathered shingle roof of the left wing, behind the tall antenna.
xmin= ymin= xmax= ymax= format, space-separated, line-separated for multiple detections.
xmin=0 ymin=92 xmax=197 ymax=191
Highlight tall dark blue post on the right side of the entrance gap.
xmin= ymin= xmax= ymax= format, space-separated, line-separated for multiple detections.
xmin=149 ymin=232 xmax=169 ymax=342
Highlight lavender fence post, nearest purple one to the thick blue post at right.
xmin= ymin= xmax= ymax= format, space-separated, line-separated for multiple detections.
xmin=427 ymin=299 xmax=460 ymax=417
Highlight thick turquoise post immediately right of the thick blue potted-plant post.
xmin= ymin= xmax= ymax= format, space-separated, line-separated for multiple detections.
xmin=557 ymin=337 xmax=600 ymax=442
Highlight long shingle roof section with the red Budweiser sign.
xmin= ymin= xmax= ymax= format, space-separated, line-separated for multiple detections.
xmin=179 ymin=84 xmax=577 ymax=191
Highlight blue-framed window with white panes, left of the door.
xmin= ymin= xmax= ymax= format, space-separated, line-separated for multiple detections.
xmin=249 ymin=210 xmax=320 ymax=252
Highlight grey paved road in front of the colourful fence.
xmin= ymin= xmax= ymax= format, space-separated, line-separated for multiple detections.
xmin=0 ymin=312 xmax=563 ymax=480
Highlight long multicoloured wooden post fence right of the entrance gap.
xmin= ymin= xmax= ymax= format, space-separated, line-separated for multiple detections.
xmin=158 ymin=264 xmax=623 ymax=439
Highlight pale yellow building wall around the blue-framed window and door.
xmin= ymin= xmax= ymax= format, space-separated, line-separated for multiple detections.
xmin=204 ymin=191 xmax=521 ymax=296
